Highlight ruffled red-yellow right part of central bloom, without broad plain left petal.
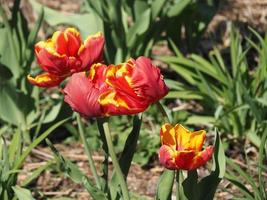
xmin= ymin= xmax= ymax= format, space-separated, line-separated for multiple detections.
xmin=99 ymin=56 xmax=168 ymax=115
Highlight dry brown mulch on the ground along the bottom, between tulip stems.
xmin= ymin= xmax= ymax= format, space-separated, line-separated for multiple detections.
xmin=18 ymin=143 xmax=236 ymax=200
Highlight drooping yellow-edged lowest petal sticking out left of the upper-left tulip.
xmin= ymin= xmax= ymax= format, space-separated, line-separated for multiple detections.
xmin=27 ymin=73 xmax=64 ymax=87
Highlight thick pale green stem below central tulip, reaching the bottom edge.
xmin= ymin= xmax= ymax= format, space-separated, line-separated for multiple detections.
xmin=101 ymin=119 xmax=130 ymax=200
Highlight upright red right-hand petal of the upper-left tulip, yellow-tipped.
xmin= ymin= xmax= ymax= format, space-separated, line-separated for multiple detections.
xmin=78 ymin=33 xmax=105 ymax=69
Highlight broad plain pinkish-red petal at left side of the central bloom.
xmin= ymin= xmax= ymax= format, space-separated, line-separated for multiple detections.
xmin=63 ymin=72 xmax=102 ymax=117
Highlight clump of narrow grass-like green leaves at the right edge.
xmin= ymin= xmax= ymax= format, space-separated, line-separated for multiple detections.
xmin=160 ymin=29 xmax=267 ymax=146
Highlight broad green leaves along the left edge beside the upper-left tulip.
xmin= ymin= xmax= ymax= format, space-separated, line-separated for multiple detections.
xmin=0 ymin=0 xmax=67 ymax=143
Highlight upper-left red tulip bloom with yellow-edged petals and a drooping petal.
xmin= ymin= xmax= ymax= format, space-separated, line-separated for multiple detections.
xmin=28 ymin=28 xmax=105 ymax=87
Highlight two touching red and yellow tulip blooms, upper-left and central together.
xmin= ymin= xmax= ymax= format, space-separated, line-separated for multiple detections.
xmin=28 ymin=28 xmax=168 ymax=117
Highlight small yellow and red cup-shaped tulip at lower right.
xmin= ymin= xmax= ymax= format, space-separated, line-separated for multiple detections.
xmin=159 ymin=124 xmax=213 ymax=170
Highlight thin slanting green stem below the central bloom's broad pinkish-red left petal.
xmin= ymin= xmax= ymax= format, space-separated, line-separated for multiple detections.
xmin=76 ymin=114 xmax=101 ymax=189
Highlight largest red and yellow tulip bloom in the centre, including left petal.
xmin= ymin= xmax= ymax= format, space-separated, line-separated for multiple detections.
xmin=64 ymin=57 xmax=168 ymax=117
